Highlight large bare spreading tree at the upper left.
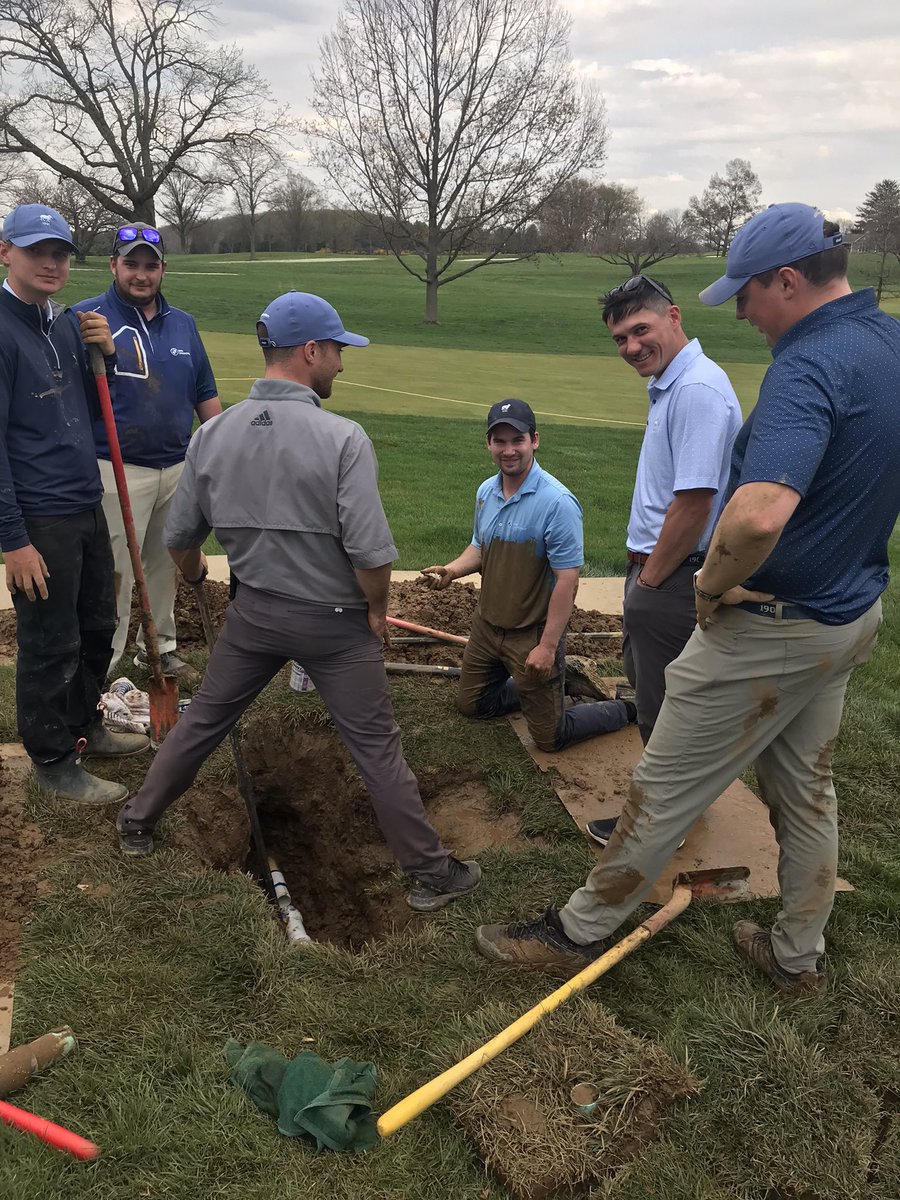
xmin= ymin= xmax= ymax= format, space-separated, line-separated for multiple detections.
xmin=0 ymin=0 xmax=283 ymax=222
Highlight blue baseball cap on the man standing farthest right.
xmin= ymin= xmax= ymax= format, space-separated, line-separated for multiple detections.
xmin=700 ymin=204 xmax=844 ymax=305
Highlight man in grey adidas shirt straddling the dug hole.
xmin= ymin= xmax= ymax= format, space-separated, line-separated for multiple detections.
xmin=118 ymin=292 xmax=481 ymax=912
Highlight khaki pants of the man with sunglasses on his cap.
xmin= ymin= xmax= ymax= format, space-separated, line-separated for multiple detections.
xmin=98 ymin=458 xmax=185 ymax=670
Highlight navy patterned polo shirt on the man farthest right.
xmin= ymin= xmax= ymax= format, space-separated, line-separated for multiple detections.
xmin=730 ymin=288 xmax=900 ymax=625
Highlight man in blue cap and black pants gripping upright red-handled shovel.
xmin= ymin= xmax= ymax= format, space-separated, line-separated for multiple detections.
xmin=0 ymin=204 xmax=150 ymax=804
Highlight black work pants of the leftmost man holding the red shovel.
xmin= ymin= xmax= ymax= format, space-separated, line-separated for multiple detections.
xmin=13 ymin=505 xmax=115 ymax=763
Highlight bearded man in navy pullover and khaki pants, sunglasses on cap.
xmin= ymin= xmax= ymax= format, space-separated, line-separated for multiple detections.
xmin=74 ymin=221 xmax=222 ymax=683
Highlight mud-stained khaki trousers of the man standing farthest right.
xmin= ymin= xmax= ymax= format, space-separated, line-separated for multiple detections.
xmin=560 ymin=601 xmax=881 ymax=971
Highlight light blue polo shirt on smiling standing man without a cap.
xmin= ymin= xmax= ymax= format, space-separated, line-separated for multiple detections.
xmin=626 ymin=337 xmax=742 ymax=554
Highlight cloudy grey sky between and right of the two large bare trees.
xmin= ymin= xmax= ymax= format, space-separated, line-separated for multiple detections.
xmin=220 ymin=0 xmax=900 ymax=223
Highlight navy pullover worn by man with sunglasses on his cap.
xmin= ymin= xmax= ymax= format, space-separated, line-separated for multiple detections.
xmin=72 ymin=283 xmax=216 ymax=469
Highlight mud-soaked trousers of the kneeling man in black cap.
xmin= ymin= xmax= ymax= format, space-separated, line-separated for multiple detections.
xmin=457 ymin=613 xmax=628 ymax=751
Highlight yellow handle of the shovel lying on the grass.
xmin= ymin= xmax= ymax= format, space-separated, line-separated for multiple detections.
xmin=378 ymin=884 xmax=692 ymax=1138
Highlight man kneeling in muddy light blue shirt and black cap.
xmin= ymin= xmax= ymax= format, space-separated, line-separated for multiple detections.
xmin=422 ymin=400 xmax=637 ymax=751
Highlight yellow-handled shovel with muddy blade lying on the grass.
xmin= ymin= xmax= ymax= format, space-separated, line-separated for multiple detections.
xmin=378 ymin=866 xmax=750 ymax=1138
